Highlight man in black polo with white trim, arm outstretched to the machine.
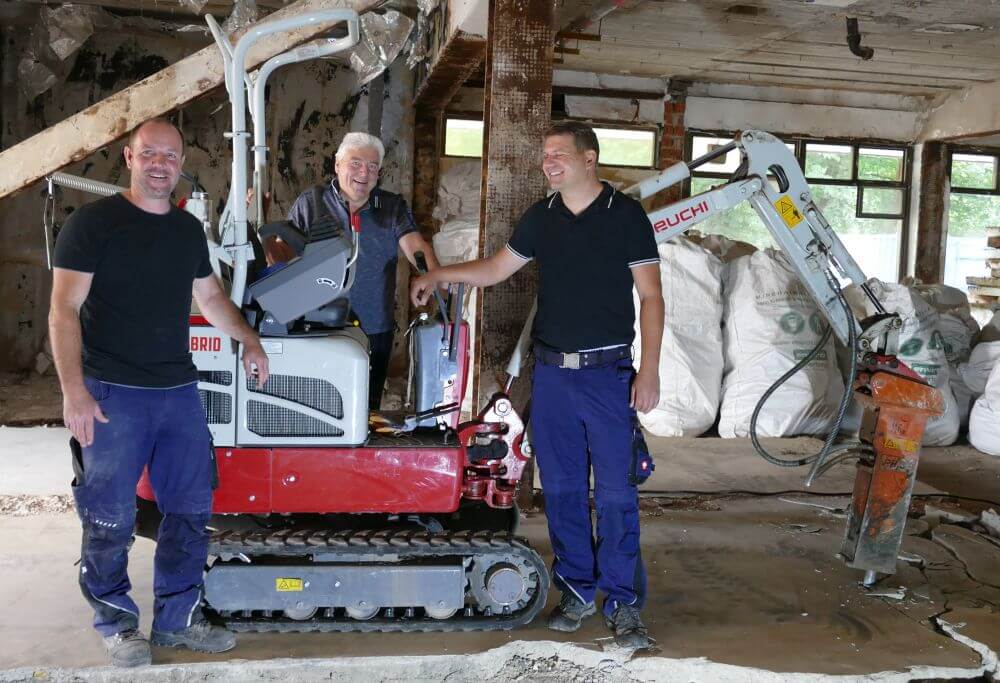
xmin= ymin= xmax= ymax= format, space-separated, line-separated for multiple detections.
xmin=411 ymin=121 xmax=663 ymax=649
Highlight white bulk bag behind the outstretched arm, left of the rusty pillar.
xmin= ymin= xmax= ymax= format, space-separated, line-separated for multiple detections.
xmin=432 ymin=159 xmax=481 ymax=419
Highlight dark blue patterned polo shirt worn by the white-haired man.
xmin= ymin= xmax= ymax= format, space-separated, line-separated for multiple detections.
xmin=288 ymin=178 xmax=417 ymax=334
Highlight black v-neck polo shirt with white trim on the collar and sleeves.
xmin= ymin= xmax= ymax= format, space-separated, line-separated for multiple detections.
xmin=507 ymin=183 xmax=660 ymax=353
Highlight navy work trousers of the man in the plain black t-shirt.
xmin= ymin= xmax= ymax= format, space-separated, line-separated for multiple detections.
xmin=73 ymin=378 xmax=215 ymax=636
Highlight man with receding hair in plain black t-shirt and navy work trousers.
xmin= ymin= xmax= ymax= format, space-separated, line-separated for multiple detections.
xmin=49 ymin=119 xmax=268 ymax=666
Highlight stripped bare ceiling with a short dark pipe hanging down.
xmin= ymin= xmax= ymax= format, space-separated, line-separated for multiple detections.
xmin=557 ymin=0 xmax=1000 ymax=97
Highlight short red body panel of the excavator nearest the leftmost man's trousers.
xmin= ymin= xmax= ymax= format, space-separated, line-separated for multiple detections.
xmin=212 ymin=448 xmax=273 ymax=513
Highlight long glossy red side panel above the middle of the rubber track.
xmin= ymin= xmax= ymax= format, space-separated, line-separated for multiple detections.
xmin=271 ymin=448 xmax=465 ymax=513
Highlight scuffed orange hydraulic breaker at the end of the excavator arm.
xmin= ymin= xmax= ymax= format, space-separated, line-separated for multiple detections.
xmin=840 ymin=356 xmax=944 ymax=585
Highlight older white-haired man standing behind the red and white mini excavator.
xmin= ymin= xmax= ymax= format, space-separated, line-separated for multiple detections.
xmin=263 ymin=133 xmax=438 ymax=410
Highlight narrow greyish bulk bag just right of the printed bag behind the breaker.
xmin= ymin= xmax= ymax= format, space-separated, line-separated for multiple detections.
xmin=914 ymin=285 xmax=982 ymax=428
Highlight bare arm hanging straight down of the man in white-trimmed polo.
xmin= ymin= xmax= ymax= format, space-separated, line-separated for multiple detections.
xmin=632 ymin=263 xmax=663 ymax=413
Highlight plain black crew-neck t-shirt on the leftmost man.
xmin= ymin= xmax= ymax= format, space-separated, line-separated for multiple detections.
xmin=54 ymin=194 xmax=212 ymax=388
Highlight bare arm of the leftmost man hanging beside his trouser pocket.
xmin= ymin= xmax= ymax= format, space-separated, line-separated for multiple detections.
xmin=49 ymin=268 xmax=108 ymax=446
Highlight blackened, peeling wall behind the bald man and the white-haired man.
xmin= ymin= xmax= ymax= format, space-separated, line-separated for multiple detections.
xmin=0 ymin=5 xmax=413 ymax=370
